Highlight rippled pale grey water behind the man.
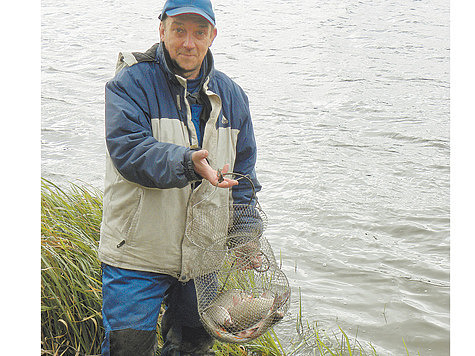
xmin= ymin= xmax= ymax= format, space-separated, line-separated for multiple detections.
xmin=41 ymin=0 xmax=450 ymax=356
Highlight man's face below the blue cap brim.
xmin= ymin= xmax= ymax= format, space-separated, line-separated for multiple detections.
xmin=160 ymin=14 xmax=217 ymax=79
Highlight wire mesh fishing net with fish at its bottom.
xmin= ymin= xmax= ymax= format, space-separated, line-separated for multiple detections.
xmin=185 ymin=173 xmax=290 ymax=343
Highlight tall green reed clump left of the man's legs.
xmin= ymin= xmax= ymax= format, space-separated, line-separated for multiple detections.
xmin=41 ymin=180 xmax=103 ymax=355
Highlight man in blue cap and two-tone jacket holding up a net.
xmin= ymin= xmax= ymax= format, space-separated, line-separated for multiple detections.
xmin=99 ymin=0 xmax=260 ymax=356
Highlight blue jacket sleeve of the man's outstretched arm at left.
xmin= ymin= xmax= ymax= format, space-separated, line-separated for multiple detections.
xmin=105 ymin=70 xmax=195 ymax=189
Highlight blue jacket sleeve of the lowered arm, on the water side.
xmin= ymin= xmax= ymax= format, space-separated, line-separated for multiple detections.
xmin=232 ymin=89 xmax=261 ymax=205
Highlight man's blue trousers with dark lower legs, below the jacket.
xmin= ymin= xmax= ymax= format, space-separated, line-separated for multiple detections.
xmin=102 ymin=264 xmax=214 ymax=356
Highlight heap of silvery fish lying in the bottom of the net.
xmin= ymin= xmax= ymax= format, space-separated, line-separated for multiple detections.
xmin=201 ymin=289 xmax=290 ymax=342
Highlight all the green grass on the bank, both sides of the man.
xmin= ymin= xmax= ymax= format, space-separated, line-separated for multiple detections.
xmin=41 ymin=179 xmax=409 ymax=356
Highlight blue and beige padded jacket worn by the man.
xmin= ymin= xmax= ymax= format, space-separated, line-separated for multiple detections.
xmin=99 ymin=44 xmax=260 ymax=282
